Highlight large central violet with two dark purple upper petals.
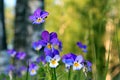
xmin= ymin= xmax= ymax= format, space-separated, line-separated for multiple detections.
xmin=42 ymin=31 xmax=62 ymax=53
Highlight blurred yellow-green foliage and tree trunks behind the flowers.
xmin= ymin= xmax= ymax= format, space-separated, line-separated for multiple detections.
xmin=0 ymin=0 xmax=120 ymax=80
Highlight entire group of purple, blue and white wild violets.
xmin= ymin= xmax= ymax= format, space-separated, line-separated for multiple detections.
xmin=5 ymin=9 xmax=92 ymax=80
